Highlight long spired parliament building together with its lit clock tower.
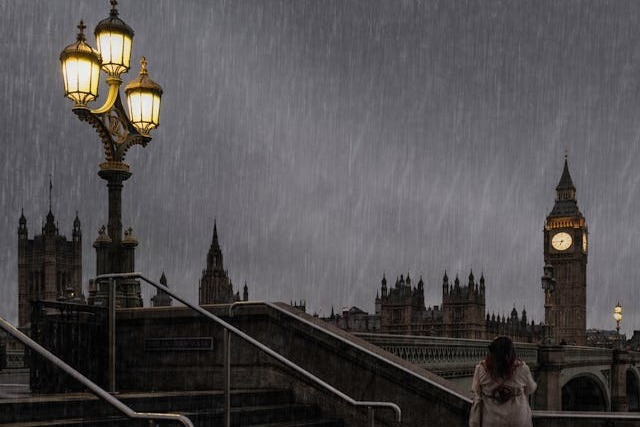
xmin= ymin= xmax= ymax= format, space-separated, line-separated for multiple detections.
xmin=326 ymin=157 xmax=588 ymax=345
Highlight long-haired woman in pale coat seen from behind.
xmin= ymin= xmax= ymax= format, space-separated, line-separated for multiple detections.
xmin=469 ymin=337 xmax=537 ymax=427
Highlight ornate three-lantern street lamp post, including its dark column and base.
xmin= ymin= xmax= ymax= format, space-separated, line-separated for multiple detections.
xmin=60 ymin=0 xmax=162 ymax=307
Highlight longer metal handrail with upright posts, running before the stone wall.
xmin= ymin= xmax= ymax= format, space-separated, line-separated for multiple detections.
xmin=95 ymin=273 xmax=402 ymax=426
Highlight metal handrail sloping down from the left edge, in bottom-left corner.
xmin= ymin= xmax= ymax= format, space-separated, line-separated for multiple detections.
xmin=0 ymin=317 xmax=193 ymax=427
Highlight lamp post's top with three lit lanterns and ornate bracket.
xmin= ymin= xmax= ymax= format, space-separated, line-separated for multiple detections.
xmin=60 ymin=0 xmax=162 ymax=171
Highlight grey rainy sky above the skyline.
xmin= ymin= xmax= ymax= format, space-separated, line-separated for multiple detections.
xmin=0 ymin=0 xmax=640 ymax=333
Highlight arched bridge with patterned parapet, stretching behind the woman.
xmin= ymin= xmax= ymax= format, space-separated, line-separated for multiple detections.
xmin=356 ymin=333 xmax=640 ymax=412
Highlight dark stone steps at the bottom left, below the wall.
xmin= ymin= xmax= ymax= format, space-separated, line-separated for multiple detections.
xmin=0 ymin=389 xmax=344 ymax=427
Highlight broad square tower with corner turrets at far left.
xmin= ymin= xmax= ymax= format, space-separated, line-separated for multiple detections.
xmin=18 ymin=206 xmax=84 ymax=329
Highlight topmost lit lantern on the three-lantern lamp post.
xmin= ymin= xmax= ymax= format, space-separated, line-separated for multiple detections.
xmin=94 ymin=0 xmax=133 ymax=77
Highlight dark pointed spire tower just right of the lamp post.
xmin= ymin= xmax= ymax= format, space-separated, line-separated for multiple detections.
xmin=198 ymin=223 xmax=249 ymax=305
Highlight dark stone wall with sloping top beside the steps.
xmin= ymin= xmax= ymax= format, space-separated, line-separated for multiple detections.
xmin=117 ymin=304 xmax=470 ymax=427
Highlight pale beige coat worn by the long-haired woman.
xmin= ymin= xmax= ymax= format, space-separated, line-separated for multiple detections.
xmin=470 ymin=361 xmax=537 ymax=427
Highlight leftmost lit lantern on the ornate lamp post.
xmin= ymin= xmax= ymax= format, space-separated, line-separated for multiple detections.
xmin=60 ymin=21 xmax=101 ymax=107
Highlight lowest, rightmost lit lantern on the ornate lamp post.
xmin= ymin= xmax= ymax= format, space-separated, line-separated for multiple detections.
xmin=124 ymin=57 xmax=162 ymax=136
